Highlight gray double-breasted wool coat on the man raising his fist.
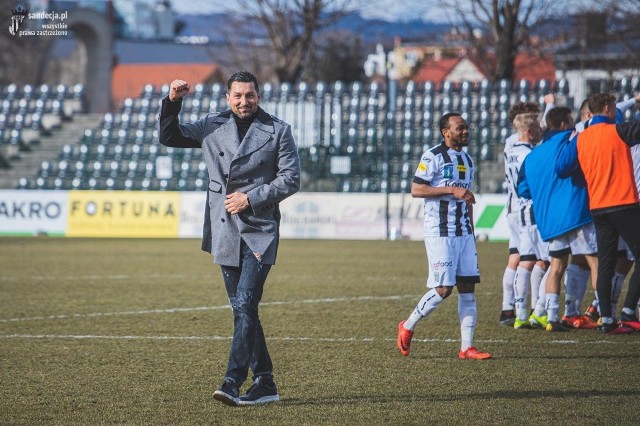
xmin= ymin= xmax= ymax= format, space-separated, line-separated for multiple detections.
xmin=159 ymin=98 xmax=300 ymax=266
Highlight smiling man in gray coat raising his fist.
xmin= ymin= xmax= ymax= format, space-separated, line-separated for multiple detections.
xmin=160 ymin=71 xmax=300 ymax=405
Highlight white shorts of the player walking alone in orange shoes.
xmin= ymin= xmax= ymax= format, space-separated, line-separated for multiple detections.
xmin=424 ymin=235 xmax=480 ymax=288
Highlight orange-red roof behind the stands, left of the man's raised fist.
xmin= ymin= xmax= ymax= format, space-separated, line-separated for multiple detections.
xmin=111 ymin=64 xmax=219 ymax=108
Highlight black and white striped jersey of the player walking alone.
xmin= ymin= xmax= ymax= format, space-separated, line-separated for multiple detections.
xmin=413 ymin=142 xmax=475 ymax=237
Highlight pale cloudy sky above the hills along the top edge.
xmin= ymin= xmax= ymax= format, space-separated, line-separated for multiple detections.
xmin=171 ymin=0 xmax=445 ymax=21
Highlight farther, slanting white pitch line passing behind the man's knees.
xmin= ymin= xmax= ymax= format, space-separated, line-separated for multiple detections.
xmin=0 ymin=295 xmax=416 ymax=323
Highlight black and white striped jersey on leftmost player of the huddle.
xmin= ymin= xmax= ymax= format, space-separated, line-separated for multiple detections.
xmin=504 ymin=142 xmax=536 ymax=226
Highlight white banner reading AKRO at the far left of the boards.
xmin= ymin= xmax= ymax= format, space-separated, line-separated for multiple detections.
xmin=0 ymin=190 xmax=69 ymax=236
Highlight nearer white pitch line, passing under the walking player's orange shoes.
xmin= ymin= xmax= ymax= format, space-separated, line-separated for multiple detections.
xmin=0 ymin=334 xmax=640 ymax=345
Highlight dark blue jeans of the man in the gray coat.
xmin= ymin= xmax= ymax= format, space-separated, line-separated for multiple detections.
xmin=221 ymin=242 xmax=273 ymax=386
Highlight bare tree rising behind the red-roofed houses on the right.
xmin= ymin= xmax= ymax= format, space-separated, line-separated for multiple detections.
xmin=438 ymin=0 xmax=554 ymax=80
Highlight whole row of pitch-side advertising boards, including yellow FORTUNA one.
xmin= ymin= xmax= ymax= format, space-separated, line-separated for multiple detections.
xmin=0 ymin=190 xmax=509 ymax=241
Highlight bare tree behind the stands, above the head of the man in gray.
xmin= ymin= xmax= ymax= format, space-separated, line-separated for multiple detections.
xmin=233 ymin=0 xmax=354 ymax=83
